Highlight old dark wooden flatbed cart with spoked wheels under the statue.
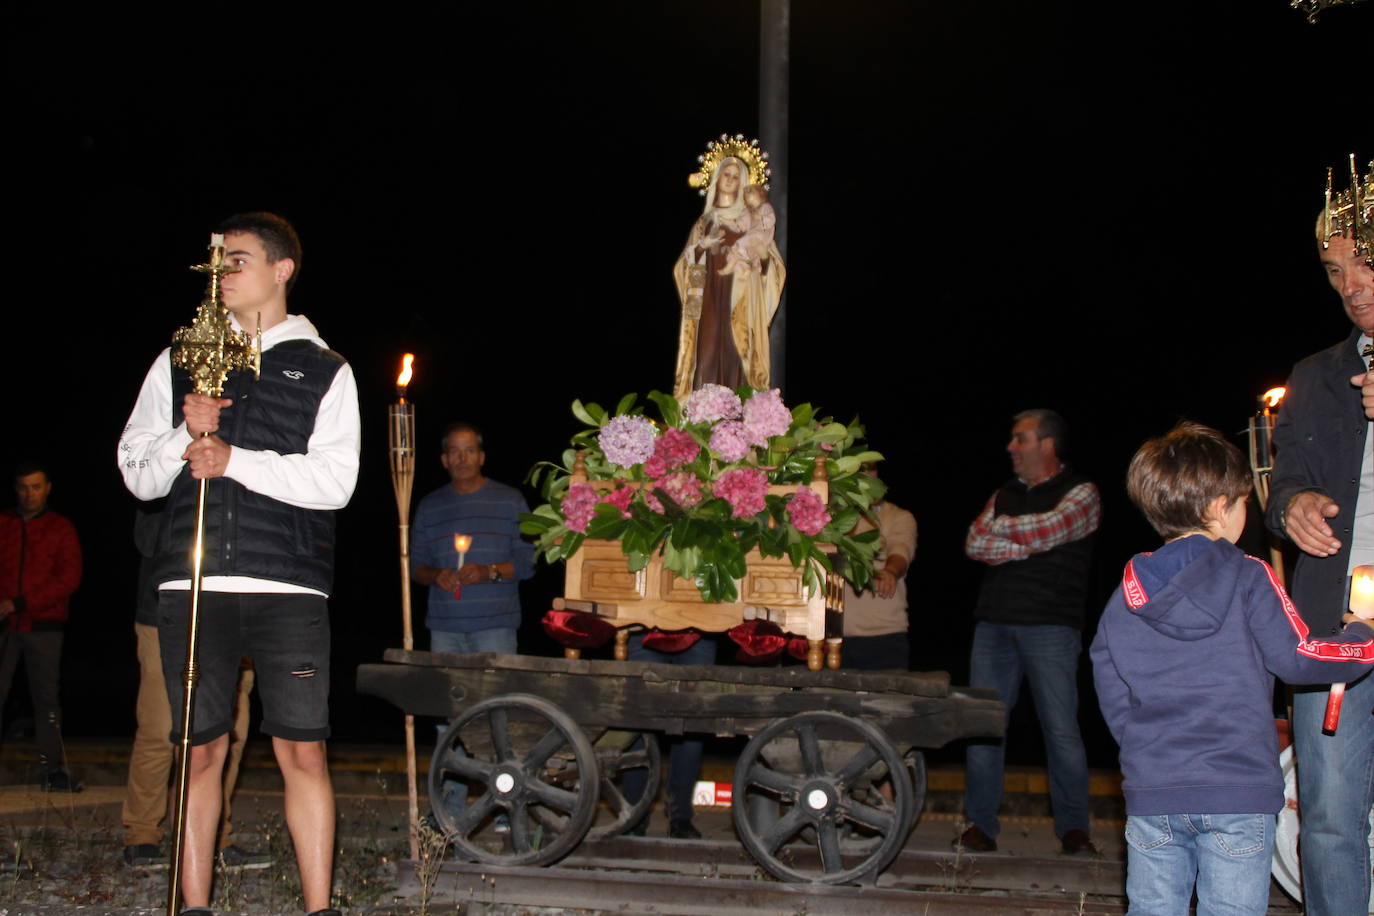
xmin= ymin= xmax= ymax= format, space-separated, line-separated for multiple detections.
xmin=357 ymin=650 xmax=1004 ymax=883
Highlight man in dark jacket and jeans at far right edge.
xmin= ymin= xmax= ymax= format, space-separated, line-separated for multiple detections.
xmin=1265 ymin=213 xmax=1374 ymax=916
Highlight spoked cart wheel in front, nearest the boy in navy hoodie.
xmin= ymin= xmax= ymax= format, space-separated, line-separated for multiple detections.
xmin=731 ymin=711 xmax=923 ymax=884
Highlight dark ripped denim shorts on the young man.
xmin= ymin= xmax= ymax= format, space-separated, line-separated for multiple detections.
xmin=158 ymin=591 xmax=330 ymax=744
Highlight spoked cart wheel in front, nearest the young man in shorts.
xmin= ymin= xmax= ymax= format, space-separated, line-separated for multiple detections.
xmin=429 ymin=694 xmax=599 ymax=865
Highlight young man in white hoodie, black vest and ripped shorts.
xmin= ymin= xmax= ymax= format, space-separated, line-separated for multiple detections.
xmin=118 ymin=213 xmax=360 ymax=915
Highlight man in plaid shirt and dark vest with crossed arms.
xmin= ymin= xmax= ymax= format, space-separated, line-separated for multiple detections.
xmin=955 ymin=409 xmax=1102 ymax=854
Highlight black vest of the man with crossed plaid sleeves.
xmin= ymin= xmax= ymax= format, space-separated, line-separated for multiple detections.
xmin=973 ymin=468 xmax=1096 ymax=629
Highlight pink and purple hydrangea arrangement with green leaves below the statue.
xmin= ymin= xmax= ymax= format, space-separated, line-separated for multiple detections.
xmin=521 ymin=385 xmax=886 ymax=602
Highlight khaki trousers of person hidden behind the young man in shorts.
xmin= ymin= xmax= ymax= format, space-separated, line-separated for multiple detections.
xmin=124 ymin=623 xmax=253 ymax=849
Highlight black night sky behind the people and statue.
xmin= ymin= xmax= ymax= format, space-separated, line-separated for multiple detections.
xmin=0 ymin=0 xmax=1374 ymax=766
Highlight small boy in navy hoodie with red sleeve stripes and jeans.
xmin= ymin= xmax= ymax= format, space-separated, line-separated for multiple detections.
xmin=1091 ymin=423 xmax=1374 ymax=916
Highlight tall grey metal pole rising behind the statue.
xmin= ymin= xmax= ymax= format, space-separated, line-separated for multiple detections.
xmin=758 ymin=0 xmax=791 ymax=387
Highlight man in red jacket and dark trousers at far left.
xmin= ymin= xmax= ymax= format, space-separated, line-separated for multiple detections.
xmin=0 ymin=464 xmax=81 ymax=792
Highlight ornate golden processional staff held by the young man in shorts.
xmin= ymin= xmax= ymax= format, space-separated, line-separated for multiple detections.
xmin=168 ymin=232 xmax=262 ymax=916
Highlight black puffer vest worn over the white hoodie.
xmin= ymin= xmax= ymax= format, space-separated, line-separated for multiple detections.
xmin=154 ymin=339 xmax=344 ymax=595
